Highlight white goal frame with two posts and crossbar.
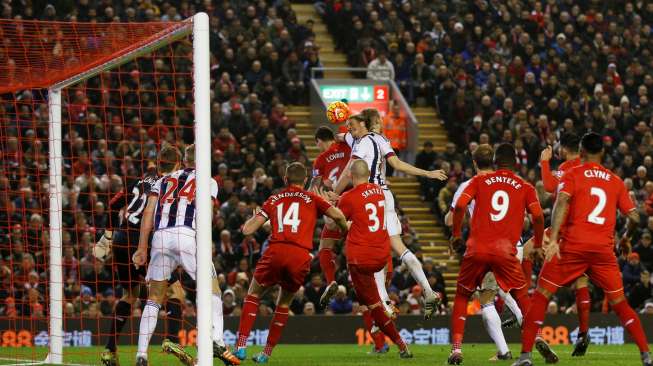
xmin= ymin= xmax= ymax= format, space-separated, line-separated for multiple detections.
xmin=44 ymin=13 xmax=213 ymax=366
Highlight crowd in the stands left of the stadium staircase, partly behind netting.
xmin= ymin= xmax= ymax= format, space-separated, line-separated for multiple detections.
xmin=0 ymin=0 xmax=444 ymax=318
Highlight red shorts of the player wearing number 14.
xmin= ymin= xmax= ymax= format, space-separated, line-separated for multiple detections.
xmin=254 ymin=243 xmax=312 ymax=292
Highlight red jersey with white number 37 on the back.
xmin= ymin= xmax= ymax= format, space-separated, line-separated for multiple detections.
xmin=338 ymin=183 xmax=390 ymax=264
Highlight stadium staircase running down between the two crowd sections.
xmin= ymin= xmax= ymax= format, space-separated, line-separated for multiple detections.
xmin=287 ymin=4 xmax=459 ymax=303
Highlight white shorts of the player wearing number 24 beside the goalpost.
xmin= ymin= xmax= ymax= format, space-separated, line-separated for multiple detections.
xmin=145 ymin=226 xmax=215 ymax=281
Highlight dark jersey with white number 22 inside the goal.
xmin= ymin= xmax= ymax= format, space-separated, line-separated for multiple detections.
xmin=109 ymin=175 xmax=159 ymax=227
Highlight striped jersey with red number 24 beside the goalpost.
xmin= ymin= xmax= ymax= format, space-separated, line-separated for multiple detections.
xmin=151 ymin=168 xmax=218 ymax=230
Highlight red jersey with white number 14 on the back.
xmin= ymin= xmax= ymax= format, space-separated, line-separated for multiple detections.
xmin=259 ymin=185 xmax=331 ymax=250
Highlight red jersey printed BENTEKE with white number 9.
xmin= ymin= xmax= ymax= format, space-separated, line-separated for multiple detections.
xmin=459 ymin=169 xmax=542 ymax=255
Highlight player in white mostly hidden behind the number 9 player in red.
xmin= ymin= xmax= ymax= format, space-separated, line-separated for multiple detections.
xmin=444 ymin=144 xmax=522 ymax=361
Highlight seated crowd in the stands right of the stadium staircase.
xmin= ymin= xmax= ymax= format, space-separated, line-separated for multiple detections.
xmin=324 ymin=0 xmax=653 ymax=312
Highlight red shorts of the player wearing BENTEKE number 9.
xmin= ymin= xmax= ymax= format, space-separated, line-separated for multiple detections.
xmin=458 ymin=253 xmax=526 ymax=294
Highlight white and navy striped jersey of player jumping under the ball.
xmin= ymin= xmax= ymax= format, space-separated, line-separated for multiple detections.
xmin=351 ymin=132 xmax=395 ymax=189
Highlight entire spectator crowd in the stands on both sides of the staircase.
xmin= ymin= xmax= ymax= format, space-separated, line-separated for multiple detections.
xmin=0 ymin=0 xmax=653 ymax=317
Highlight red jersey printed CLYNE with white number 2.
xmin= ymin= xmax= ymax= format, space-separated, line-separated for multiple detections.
xmin=558 ymin=163 xmax=635 ymax=251
